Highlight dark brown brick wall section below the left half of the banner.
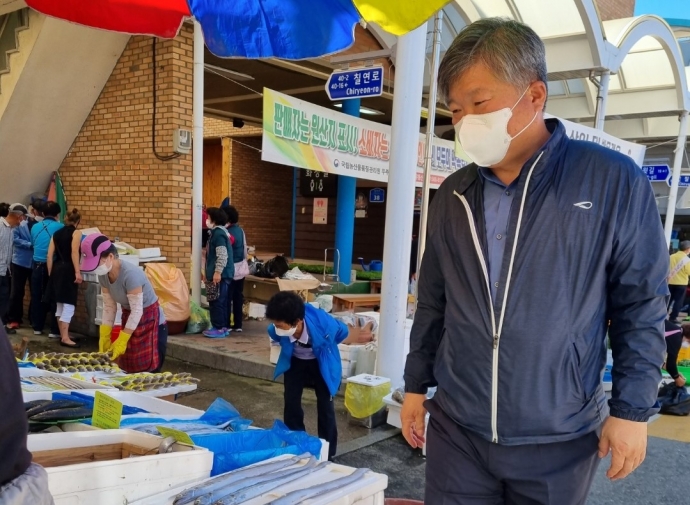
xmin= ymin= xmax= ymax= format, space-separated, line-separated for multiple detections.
xmin=230 ymin=137 xmax=293 ymax=255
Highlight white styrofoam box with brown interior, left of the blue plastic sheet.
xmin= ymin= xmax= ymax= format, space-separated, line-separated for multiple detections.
xmin=27 ymin=430 xmax=213 ymax=505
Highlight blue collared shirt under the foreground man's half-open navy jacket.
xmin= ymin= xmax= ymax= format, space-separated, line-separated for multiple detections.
xmin=479 ymin=167 xmax=517 ymax=301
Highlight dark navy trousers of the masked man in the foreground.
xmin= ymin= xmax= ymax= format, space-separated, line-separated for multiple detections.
xmin=424 ymin=400 xmax=599 ymax=505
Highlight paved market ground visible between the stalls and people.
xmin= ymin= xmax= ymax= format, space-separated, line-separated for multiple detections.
xmin=11 ymin=321 xmax=690 ymax=505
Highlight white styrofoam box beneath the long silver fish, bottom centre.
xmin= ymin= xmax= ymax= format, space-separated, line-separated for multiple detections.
xmin=130 ymin=456 xmax=388 ymax=505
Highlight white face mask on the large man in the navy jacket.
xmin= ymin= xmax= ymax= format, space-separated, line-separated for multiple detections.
xmin=455 ymin=87 xmax=537 ymax=167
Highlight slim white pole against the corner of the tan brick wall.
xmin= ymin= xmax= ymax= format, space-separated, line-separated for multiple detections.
xmin=191 ymin=21 xmax=204 ymax=304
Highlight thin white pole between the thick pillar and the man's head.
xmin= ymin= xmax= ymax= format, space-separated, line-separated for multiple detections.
xmin=417 ymin=10 xmax=443 ymax=280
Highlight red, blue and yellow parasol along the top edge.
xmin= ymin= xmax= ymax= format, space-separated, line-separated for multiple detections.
xmin=26 ymin=0 xmax=450 ymax=59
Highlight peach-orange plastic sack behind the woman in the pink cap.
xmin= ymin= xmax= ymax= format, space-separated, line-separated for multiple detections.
xmin=145 ymin=263 xmax=190 ymax=321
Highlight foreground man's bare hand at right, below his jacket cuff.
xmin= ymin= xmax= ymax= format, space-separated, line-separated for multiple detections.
xmin=599 ymin=417 xmax=647 ymax=481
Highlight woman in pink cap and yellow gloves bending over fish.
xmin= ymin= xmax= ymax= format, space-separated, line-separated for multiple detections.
xmin=81 ymin=233 xmax=168 ymax=373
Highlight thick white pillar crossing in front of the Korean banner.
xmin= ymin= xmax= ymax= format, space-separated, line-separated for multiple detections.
xmin=377 ymin=23 xmax=427 ymax=387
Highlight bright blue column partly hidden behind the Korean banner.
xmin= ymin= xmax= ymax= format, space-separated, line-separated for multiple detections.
xmin=334 ymin=98 xmax=361 ymax=284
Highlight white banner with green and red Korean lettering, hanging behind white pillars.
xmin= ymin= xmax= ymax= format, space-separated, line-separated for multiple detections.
xmin=261 ymin=88 xmax=468 ymax=189
